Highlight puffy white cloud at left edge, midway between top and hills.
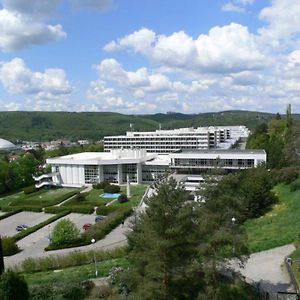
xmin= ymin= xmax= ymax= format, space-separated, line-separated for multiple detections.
xmin=0 ymin=58 xmax=72 ymax=100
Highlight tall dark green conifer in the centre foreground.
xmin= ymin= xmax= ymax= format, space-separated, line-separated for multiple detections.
xmin=125 ymin=179 xmax=203 ymax=300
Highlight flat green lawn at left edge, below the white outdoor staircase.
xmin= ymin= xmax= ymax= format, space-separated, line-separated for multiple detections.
xmin=0 ymin=188 xmax=79 ymax=207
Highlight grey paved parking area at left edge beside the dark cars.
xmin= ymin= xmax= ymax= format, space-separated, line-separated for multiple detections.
xmin=0 ymin=211 xmax=53 ymax=236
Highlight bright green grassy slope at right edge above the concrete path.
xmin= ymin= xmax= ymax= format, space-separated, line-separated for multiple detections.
xmin=245 ymin=184 xmax=300 ymax=252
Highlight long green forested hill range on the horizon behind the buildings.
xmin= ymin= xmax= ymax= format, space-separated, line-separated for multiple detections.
xmin=0 ymin=111 xmax=300 ymax=141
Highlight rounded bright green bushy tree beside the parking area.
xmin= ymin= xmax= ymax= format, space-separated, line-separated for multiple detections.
xmin=51 ymin=219 xmax=80 ymax=246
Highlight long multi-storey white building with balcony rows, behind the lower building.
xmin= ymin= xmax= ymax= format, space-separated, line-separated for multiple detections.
xmin=104 ymin=126 xmax=249 ymax=153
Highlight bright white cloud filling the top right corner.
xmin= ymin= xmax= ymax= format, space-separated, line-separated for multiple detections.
xmin=259 ymin=0 xmax=300 ymax=45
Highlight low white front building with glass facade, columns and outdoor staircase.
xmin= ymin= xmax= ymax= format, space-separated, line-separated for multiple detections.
xmin=40 ymin=150 xmax=266 ymax=187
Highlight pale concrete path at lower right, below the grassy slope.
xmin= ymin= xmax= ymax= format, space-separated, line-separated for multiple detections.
xmin=230 ymin=244 xmax=295 ymax=299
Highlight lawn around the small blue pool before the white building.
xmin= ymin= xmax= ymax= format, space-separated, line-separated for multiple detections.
xmin=64 ymin=184 xmax=148 ymax=207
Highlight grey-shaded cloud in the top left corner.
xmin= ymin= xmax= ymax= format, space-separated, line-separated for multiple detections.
xmin=0 ymin=0 xmax=66 ymax=52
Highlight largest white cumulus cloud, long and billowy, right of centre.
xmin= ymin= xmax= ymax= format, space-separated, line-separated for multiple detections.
xmin=104 ymin=23 xmax=266 ymax=73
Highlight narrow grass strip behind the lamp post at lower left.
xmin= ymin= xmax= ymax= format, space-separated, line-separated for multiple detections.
xmin=23 ymin=257 xmax=129 ymax=285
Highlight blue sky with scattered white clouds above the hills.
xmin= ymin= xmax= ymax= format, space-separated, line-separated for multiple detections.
xmin=0 ymin=0 xmax=300 ymax=114
